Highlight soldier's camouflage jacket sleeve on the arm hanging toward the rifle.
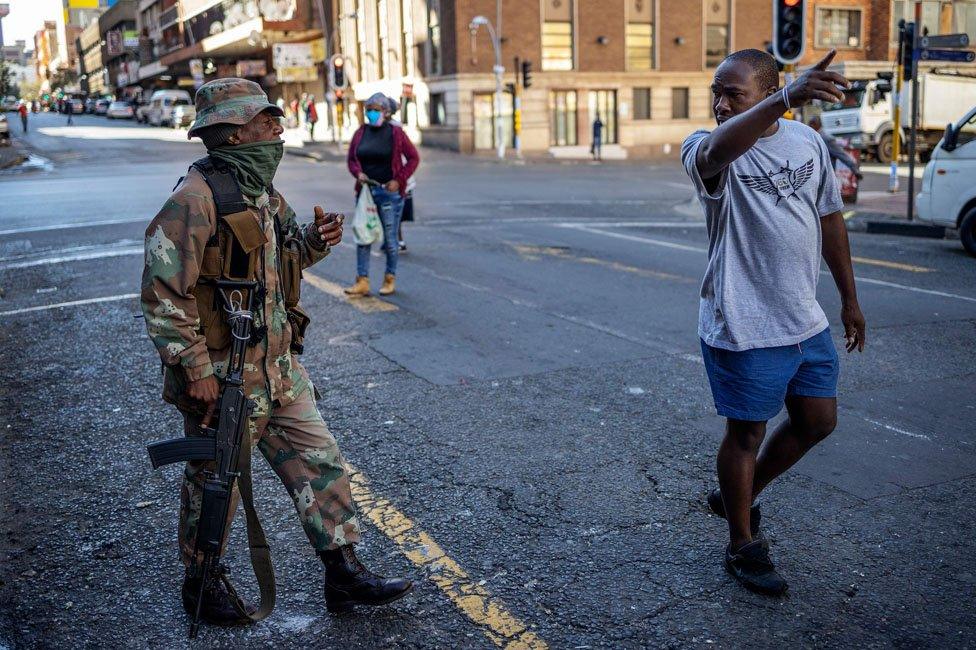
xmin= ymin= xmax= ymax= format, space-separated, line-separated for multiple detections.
xmin=142 ymin=179 xmax=216 ymax=381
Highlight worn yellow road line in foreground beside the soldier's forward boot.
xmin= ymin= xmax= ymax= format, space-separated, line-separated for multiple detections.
xmin=350 ymin=467 xmax=549 ymax=650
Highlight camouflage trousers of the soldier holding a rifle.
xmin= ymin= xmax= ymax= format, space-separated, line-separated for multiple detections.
xmin=179 ymin=387 xmax=359 ymax=566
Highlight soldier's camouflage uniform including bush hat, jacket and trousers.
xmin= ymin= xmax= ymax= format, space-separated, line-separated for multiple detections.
xmin=142 ymin=80 xmax=359 ymax=565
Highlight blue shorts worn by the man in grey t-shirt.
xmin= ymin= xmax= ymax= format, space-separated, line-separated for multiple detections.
xmin=701 ymin=328 xmax=840 ymax=422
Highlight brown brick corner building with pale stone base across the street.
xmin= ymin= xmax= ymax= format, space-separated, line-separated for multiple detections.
xmin=329 ymin=0 xmax=976 ymax=156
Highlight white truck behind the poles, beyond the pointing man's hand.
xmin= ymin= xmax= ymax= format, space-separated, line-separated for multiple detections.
xmin=821 ymin=61 xmax=976 ymax=163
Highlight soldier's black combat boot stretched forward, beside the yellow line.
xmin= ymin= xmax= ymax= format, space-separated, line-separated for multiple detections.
xmin=319 ymin=544 xmax=413 ymax=613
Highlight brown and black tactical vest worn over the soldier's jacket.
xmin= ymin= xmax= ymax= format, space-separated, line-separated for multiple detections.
xmin=181 ymin=156 xmax=309 ymax=354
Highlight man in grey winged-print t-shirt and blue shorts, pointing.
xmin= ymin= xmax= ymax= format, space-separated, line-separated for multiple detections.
xmin=681 ymin=50 xmax=865 ymax=595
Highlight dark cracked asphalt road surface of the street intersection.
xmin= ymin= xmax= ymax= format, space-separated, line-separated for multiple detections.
xmin=0 ymin=109 xmax=976 ymax=648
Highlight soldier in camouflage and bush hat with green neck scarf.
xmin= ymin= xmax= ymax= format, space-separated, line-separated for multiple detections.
xmin=142 ymin=78 xmax=413 ymax=625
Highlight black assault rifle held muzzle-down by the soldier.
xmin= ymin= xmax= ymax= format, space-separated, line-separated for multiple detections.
xmin=148 ymin=280 xmax=266 ymax=639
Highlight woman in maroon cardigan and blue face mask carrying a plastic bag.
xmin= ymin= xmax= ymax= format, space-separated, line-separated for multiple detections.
xmin=346 ymin=93 xmax=420 ymax=296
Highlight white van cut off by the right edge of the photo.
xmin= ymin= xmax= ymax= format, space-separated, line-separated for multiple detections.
xmin=915 ymin=107 xmax=976 ymax=256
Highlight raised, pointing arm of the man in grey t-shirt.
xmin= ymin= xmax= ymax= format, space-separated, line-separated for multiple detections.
xmin=695 ymin=50 xmax=850 ymax=179
